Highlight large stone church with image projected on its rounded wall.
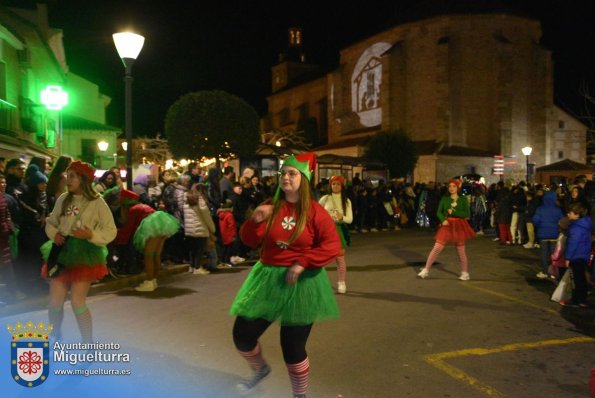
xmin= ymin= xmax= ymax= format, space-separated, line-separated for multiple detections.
xmin=262 ymin=14 xmax=587 ymax=182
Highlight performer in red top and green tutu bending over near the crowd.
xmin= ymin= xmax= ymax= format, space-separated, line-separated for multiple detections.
xmin=114 ymin=189 xmax=180 ymax=292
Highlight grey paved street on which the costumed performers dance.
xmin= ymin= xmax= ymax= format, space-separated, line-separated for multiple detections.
xmin=0 ymin=230 xmax=595 ymax=398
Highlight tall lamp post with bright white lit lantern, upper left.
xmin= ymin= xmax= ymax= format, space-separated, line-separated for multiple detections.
xmin=112 ymin=32 xmax=145 ymax=189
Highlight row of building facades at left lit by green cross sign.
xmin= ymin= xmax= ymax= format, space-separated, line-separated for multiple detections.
xmin=0 ymin=4 xmax=121 ymax=168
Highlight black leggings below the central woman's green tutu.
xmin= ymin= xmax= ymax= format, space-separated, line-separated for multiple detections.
xmin=233 ymin=316 xmax=312 ymax=364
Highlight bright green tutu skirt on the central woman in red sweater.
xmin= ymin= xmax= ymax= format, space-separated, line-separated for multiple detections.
xmin=230 ymin=261 xmax=339 ymax=325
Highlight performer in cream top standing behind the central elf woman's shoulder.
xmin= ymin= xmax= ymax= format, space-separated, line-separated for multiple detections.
xmin=319 ymin=176 xmax=353 ymax=294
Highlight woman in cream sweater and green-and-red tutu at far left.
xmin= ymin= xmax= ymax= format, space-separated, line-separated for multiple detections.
xmin=41 ymin=160 xmax=116 ymax=343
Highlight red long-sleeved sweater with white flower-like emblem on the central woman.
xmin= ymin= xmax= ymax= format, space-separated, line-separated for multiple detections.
xmin=240 ymin=200 xmax=341 ymax=268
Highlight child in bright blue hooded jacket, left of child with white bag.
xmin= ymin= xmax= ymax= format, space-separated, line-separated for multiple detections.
xmin=533 ymin=191 xmax=564 ymax=279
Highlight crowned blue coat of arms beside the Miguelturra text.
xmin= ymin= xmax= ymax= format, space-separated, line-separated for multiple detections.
xmin=8 ymin=321 xmax=53 ymax=387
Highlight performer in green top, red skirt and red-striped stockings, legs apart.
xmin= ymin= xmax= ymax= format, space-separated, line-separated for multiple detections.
xmin=417 ymin=180 xmax=475 ymax=281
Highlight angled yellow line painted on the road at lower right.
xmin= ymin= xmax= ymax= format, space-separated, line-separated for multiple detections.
xmin=423 ymin=337 xmax=595 ymax=398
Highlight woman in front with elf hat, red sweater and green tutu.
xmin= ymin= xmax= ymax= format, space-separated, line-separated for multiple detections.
xmin=230 ymin=153 xmax=341 ymax=398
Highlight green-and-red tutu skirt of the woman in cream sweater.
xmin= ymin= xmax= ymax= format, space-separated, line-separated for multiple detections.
xmin=40 ymin=236 xmax=108 ymax=283
